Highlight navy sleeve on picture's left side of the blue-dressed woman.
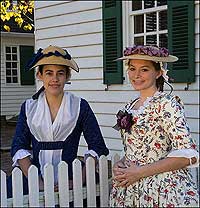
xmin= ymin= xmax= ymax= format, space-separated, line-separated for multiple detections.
xmin=11 ymin=102 xmax=31 ymax=157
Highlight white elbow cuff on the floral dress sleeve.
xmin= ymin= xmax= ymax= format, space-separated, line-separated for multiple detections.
xmin=167 ymin=149 xmax=199 ymax=168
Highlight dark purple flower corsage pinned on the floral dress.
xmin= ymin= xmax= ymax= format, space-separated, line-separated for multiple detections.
xmin=113 ymin=110 xmax=135 ymax=133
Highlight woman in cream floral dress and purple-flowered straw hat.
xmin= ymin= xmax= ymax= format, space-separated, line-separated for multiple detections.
xmin=110 ymin=46 xmax=199 ymax=207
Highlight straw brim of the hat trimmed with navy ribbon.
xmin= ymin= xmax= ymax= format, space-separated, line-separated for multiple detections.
xmin=31 ymin=56 xmax=79 ymax=72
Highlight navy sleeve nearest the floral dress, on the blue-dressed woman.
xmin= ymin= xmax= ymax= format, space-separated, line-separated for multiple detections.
xmin=82 ymin=99 xmax=109 ymax=157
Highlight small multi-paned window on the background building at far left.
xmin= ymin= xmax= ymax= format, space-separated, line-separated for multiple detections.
xmin=5 ymin=46 xmax=19 ymax=84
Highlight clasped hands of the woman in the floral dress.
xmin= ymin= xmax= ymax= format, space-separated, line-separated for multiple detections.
xmin=114 ymin=162 xmax=141 ymax=187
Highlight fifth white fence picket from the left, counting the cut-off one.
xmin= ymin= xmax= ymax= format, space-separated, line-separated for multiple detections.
xmin=58 ymin=161 xmax=69 ymax=207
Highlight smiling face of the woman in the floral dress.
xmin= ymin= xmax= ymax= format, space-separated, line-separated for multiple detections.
xmin=128 ymin=59 xmax=162 ymax=91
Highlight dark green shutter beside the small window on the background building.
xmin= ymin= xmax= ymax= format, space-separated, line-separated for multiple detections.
xmin=19 ymin=45 xmax=35 ymax=85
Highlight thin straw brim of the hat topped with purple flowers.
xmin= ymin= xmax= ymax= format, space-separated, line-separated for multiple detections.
xmin=116 ymin=54 xmax=178 ymax=63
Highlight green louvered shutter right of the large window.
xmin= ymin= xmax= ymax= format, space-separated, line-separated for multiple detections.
xmin=168 ymin=0 xmax=195 ymax=83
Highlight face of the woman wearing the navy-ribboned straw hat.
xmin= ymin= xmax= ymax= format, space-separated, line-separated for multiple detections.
xmin=37 ymin=65 xmax=67 ymax=96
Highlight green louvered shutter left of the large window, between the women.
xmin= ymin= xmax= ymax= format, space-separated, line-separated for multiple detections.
xmin=102 ymin=0 xmax=123 ymax=84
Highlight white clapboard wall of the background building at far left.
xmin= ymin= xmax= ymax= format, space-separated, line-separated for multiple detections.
xmin=1 ymin=33 xmax=36 ymax=116
